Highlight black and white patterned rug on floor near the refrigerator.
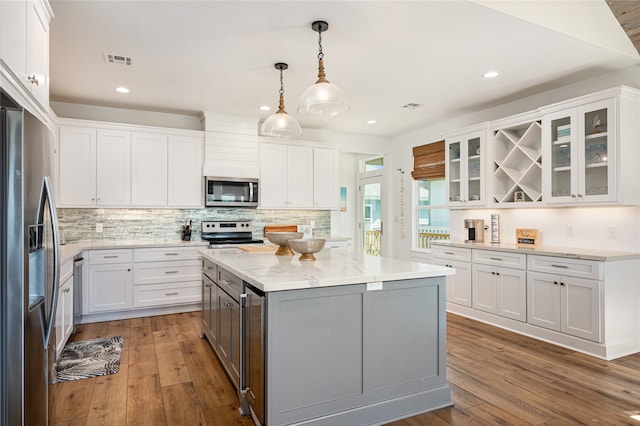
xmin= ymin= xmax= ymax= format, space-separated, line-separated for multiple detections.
xmin=56 ymin=336 xmax=124 ymax=382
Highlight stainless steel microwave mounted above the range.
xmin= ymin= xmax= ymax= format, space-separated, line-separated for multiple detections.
xmin=204 ymin=176 xmax=258 ymax=207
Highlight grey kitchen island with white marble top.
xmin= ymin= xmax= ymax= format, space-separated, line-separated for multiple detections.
xmin=201 ymin=249 xmax=454 ymax=425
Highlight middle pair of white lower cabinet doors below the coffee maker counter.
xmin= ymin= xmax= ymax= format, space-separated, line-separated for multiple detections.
xmin=472 ymin=264 xmax=527 ymax=322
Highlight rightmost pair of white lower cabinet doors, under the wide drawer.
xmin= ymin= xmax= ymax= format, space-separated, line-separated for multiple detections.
xmin=527 ymin=272 xmax=602 ymax=342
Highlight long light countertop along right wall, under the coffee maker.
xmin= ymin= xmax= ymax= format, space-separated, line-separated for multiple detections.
xmin=431 ymin=241 xmax=640 ymax=262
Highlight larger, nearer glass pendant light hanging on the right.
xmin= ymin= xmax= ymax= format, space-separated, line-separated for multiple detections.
xmin=298 ymin=21 xmax=349 ymax=117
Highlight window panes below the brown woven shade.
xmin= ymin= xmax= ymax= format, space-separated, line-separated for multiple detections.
xmin=415 ymin=178 xmax=450 ymax=249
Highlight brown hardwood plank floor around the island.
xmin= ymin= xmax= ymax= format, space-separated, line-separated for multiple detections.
xmin=55 ymin=312 xmax=640 ymax=426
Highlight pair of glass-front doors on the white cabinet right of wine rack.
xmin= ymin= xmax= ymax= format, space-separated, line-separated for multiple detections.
xmin=543 ymin=99 xmax=616 ymax=204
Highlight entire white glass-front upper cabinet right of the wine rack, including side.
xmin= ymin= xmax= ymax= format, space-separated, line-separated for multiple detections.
xmin=542 ymin=87 xmax=640 ymax=205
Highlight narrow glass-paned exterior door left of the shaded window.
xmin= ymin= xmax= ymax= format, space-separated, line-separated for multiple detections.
xmin=358 ymin=172 xmax=384 ymax=256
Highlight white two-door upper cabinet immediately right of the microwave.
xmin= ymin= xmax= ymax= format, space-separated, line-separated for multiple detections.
xmin=259 ymin=142 xmax=339 ymax=210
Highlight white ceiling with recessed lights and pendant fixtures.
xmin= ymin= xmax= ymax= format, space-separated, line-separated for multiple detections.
xmin=50 ymin=0 xmax=640 ymax=136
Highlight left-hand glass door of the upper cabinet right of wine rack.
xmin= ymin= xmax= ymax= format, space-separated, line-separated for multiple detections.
xmin=548 ymin=115 xmax=576 ymax=198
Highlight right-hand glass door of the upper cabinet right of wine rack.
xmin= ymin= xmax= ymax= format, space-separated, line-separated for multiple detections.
xmin=579 ymin=105 xmax=613 ymax=198
